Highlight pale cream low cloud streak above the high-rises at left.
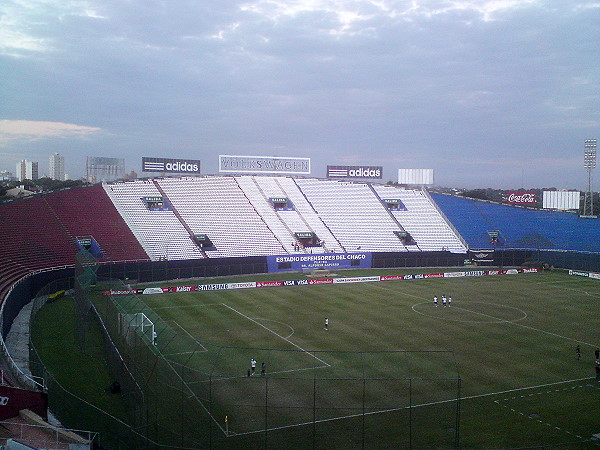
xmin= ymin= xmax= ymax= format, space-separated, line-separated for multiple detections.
xmin=0 ymin=120 xmax=101 ymax=145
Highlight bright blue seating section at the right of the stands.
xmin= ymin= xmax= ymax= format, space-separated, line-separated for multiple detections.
xmin=431 ymin=194 xmax=600 ymax=252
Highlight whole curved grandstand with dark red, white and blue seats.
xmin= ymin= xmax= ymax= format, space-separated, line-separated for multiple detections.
xmin=0 ymin=175 xmax=600 ymax=446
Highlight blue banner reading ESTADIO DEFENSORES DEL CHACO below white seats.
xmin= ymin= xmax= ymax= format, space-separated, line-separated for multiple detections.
xmin=267 ymin=252 xmax=371 ymax=272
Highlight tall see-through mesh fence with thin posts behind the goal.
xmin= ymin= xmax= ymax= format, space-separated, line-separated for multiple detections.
xmin=88 ymin=280 xmax=460 ymax=448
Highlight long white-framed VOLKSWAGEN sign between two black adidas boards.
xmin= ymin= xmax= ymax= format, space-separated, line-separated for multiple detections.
xmin=219 ymin=155 xmax=310 ymax=175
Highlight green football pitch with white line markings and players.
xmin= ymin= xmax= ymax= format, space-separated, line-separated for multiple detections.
xmin=103 ymin=269 xmax=600 ymax=448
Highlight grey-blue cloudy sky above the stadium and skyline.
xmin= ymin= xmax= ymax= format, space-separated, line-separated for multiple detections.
xmin=0 ymin=0 xmax=600 ymax=189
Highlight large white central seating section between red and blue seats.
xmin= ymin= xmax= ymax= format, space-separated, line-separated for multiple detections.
xmin=105 ymin=176 xmax=466 ymax=260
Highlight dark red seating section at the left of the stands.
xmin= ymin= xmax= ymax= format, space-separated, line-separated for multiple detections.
xmin=0 ymin=185 xmax=148 ymax=300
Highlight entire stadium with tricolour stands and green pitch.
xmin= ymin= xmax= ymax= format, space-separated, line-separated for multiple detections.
xmin=0 ymin=175 xmax=600 ymax=448
